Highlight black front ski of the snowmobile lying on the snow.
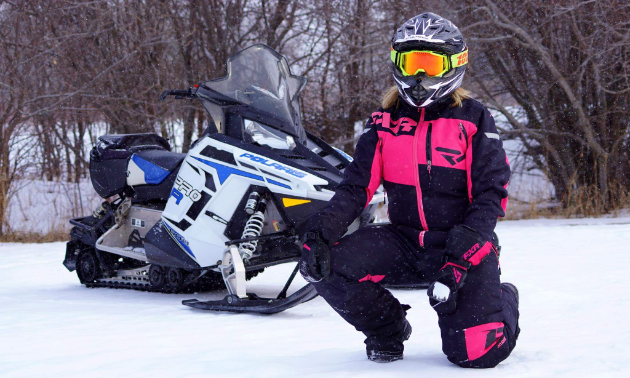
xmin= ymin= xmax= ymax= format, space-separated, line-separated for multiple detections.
xmin=182 ymin=284 xmax=317 ymax=315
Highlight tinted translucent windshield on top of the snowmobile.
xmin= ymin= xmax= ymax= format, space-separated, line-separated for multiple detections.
xmin=202 ymin=45 xmax=306 ymax=142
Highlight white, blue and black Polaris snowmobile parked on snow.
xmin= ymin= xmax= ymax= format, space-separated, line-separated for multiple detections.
xmin=63 ymin=45 xmax=384 ymax=314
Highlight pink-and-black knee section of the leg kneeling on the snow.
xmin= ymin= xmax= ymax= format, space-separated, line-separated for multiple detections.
xmin=442 ymin=322 xmax=516 ymax=369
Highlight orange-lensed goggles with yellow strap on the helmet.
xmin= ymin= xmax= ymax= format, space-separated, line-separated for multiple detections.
xmin=391 ymin=48 xmax=468 ymax=77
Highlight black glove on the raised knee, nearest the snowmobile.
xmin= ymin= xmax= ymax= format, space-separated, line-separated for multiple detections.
xmin=300 ymin=232 xmax=330 ymax=282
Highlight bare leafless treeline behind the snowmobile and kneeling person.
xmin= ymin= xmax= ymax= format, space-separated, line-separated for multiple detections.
xmin=0 ymin=0 xmax=630 ymax=237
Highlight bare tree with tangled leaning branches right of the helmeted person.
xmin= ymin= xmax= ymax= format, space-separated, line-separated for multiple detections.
xmin=459 ymin=0 xmax=630 ymax=211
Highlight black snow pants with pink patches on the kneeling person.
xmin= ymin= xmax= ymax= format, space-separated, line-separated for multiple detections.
xmin=314 ymin=224 xmax=519 ymax=368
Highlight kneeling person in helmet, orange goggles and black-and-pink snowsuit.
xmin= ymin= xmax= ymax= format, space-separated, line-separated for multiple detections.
xmin=300 ymin=13 xmax=520 ymax=368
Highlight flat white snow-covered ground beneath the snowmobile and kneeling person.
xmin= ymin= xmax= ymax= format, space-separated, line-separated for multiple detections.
xmin=0 ymin=217 xmax=630 ymax=378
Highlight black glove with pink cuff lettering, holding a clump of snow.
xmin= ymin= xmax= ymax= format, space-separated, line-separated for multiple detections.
xmin=427 ymin=225 xmax=495 ymax=315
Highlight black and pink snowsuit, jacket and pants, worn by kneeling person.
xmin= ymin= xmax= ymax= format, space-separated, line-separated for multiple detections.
xmin=307 ymin=96 xmax=518 ymax=367
